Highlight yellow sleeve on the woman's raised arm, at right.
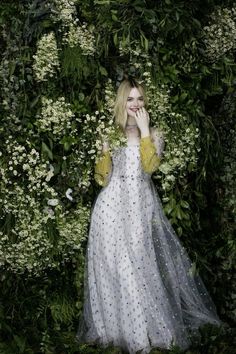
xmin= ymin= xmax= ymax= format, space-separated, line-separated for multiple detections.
xmin=140 ymin=136 xmax=160 ymax=174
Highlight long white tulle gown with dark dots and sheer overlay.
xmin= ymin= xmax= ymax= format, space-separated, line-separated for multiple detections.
xmin=76 ymin=145 xmax=220 ymax=353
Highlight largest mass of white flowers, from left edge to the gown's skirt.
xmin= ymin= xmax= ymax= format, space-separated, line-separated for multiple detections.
xmin=0 ymin=136 xmax=90 ymax=275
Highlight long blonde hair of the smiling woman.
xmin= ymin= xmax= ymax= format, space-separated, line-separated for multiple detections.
xmin=114 ymin=78 xmax=147 ymax=132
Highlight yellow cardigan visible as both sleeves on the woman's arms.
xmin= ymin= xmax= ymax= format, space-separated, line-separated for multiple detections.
xmin=94 ymin=136 xmax=160 ymax=187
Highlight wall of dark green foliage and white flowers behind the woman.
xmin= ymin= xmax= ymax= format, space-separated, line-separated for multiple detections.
xmin=0 ymin=0 xmax=236 ymax=354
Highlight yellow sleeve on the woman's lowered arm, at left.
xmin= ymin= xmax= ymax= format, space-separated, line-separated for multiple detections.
xmin=94 ymin=151 xmax=112 ymax=187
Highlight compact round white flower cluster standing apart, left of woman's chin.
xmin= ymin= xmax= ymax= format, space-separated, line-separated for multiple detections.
xmin=36 ymin=97 xmax=74 ymax=138
